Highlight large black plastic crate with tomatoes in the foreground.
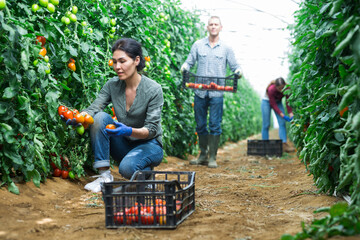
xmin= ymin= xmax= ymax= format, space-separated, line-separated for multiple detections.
xmin=102 ymin=171 xmax=195 ymax=228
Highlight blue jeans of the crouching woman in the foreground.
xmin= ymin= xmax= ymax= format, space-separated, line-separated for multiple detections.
xmin=90 ymin=112 xmax=164 ymax=179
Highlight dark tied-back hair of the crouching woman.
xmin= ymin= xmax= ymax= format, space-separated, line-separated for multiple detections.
xmin=111 ymin=38 xmax=145 ymax=71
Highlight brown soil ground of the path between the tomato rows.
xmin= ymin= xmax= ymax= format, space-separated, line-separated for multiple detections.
xmin=0 ymin=131 xmax=360 ymax=240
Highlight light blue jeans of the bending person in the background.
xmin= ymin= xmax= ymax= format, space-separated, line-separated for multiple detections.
xmin=261 ymin=99 xmax=287 ymax=142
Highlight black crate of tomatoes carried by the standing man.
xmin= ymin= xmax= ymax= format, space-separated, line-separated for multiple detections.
xmin=182 ymin=71 xmax=239 ymax=93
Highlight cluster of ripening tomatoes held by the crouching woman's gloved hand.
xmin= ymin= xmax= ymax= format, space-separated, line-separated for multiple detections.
xmin=58 ymin=105 xmax=94 ymax=135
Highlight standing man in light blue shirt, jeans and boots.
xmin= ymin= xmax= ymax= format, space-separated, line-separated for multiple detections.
xmin=181 ymin=16 xmax=241 ymax=168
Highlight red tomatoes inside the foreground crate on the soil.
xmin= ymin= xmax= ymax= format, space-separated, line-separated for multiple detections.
xmin=114 ymin=199 xmax=182 ymax=225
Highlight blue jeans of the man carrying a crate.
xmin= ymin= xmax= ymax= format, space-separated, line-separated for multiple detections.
xmin=194 ymin=95 xmax=224 ymax=135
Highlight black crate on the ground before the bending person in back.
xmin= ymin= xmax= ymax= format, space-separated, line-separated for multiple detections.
xmin=247 ymin=140 xmax=282 ymax=157
